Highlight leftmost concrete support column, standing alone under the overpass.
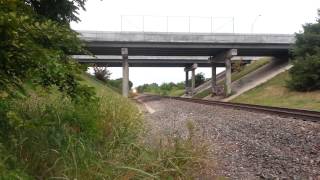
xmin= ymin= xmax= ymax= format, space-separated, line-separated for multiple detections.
xmin=121 ymin=48 xmax=129 ymax=97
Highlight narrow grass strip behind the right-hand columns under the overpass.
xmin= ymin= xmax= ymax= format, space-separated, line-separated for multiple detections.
xmin=194 ymin=58 xmax=270 ymax=98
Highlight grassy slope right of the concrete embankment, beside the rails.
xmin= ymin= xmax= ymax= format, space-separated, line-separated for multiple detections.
xmin=232 ymin=72 xmax=320 ymax=111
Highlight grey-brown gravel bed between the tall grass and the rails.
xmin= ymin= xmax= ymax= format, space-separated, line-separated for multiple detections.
xmin=138 ymin=96 xmax=320 ymax=180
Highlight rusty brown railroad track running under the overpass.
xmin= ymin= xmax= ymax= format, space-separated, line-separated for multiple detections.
xmin=147 ymin=95 xmax=320 ymax=123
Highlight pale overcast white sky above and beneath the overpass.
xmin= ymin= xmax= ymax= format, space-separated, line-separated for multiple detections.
xmin=71 ymin=0 xmax=320 ymax=86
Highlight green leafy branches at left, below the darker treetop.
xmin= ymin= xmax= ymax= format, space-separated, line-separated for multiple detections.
xmin=0 ymin=0 xmax=93 ymax=99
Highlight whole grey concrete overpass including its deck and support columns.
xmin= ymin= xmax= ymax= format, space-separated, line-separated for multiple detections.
xmin=75 ymin=31 xmax=295 ymax=96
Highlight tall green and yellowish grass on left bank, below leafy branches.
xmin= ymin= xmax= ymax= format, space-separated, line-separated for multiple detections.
xmin=0 ymin=77 xmax=208 ymax=179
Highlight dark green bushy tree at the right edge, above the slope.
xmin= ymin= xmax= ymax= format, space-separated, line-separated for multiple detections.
xmin=288 ymin=13 xmax=320 ymax=91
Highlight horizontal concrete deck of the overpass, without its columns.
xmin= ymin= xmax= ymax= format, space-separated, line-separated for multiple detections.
xmin=78 ymin=31 xmax=295 ymax=67
